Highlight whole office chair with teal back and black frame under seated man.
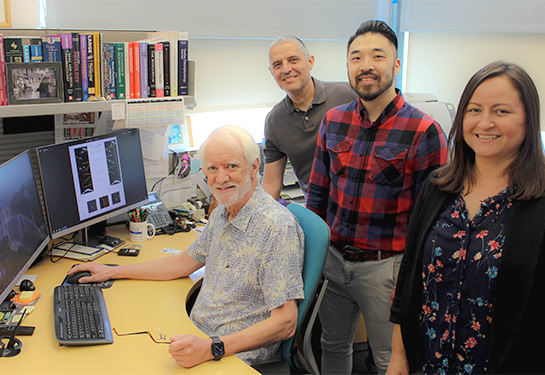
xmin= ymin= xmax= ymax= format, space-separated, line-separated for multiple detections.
xmin=282 ymin=203 xmax=330 ymax=374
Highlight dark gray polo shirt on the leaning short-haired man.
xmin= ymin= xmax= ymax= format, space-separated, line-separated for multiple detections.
xmin=263 ymin=78 xmax=358 ymax=193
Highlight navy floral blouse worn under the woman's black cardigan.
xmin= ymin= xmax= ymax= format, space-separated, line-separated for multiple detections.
xmin=420 ymin=189 xmax=512 ymax=374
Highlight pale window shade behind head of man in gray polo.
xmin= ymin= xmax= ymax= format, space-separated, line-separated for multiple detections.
xmin=189 ymin=39 xmax=347 ymax=112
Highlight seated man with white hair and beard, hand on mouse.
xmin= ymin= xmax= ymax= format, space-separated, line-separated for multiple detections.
xmin=68 ymin=126 xmax=304 ymax=367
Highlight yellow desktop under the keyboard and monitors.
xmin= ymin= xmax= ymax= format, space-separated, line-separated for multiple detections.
xmin=0 ymin=226 xmax=257 ymax=374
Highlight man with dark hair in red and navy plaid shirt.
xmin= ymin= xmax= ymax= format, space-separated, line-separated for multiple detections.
xmin=307 ymin=21 xmax=447 ymax=374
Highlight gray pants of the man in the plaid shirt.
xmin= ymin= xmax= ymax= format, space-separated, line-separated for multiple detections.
xmin=319 ymin=246 xmax=402 ymax=374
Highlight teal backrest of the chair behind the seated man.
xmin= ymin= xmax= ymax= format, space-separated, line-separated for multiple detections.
xmin=282 ymin=203 xmax=330 ymax=367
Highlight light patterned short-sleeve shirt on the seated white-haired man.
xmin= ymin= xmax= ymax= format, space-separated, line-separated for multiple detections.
xmin=187 ymin=186 xmax=304 ymax=364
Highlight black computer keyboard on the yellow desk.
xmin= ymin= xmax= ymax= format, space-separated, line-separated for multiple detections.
xmin=53 ymin=284 xmax=114 ymax=345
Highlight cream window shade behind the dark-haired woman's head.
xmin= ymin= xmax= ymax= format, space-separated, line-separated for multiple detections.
xmin=405 ymin=32 xmax=545 ymax=129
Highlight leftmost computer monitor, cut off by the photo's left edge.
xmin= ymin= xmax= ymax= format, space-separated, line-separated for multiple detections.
xmin=0 ymin=151 xmax=50 ymax=303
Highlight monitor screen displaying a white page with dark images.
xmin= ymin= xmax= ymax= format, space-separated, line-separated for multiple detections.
xmin=36 ymin=129 xmax=148 ymax=238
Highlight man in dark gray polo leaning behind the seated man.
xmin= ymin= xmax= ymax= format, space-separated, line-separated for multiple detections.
xmin=262 ymin=35 xmax=357 ymax=199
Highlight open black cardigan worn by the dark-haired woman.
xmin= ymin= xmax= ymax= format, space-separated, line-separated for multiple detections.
xmin=390 ymin=179 xmax=545 ymax=374
